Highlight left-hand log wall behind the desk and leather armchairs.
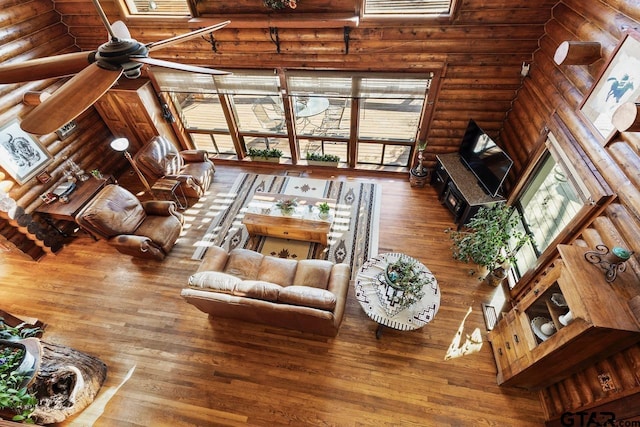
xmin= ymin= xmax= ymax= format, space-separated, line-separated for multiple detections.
xmin=0 ymin=0 xmax=126 ymax=259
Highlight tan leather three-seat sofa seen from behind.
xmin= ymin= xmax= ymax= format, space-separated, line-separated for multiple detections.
xmin=181 ymin=246 xmax=350 ymax=336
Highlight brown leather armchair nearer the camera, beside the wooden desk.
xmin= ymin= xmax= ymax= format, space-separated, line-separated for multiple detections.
xmin=76 ymin=184 xmax=184 ymax=260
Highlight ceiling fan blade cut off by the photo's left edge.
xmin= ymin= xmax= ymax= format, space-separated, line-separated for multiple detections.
xmin=0 ymin=52 xmax=95 ymax=84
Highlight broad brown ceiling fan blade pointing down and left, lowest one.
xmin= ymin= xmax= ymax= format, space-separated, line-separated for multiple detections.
xmin=20 ymin=64 xmax=122 ymax=135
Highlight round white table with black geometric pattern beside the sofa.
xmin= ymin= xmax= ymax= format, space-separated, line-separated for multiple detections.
xmin=355 ymin=253 xmax=440 ymax=338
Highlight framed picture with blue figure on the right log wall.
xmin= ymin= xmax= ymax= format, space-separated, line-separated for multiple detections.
xmin=580 ymin=31 xmax=640 ymax=144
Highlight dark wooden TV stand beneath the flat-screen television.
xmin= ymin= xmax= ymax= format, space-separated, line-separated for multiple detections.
xmin=431 ymin=153 xmax=506 ymax=230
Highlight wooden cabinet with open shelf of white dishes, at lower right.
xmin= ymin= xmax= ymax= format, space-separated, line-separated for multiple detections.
xmin=489 ymin=245 xmax=640 ymax=390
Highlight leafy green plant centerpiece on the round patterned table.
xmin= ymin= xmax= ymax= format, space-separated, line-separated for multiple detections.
xmin=384 ymin=258 xmax=433 ymax=308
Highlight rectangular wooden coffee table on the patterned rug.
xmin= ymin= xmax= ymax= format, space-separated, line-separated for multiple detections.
xmin=242 ymin=192 xmax=336 ymax=246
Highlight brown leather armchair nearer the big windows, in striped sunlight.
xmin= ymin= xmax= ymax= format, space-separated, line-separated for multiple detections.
xmin=134 ymin=136 xmax=215 ymax=199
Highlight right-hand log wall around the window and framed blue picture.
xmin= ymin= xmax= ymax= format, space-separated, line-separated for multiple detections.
xmin=500 ymin=0 xmax=640 ymax=425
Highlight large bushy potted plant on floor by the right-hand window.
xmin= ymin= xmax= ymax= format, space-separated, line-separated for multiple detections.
xmin=450 ymin=203 xmax=531 ymax=280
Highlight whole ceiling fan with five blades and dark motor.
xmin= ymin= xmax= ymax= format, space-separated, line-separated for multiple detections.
xmin=0 ymin=0 xmax=230 ymax=135
